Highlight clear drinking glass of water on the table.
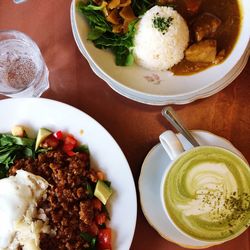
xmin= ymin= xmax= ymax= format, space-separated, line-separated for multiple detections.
xmin=0 ymin=30 xmax=49 ymax=97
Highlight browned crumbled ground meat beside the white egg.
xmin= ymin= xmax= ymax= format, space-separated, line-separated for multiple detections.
xmin=9 ymin=148 xmax=109 ymax=250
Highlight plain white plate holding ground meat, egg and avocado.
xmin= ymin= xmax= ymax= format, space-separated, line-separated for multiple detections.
xmin=0 ymin=98 xmax=137 ymax=250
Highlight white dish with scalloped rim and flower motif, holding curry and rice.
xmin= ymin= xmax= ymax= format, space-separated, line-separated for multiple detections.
xmin=70 ymin=0 xmax=250 ymax=105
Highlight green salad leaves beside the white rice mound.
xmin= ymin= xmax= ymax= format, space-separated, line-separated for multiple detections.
xmin=76 ymin=0 xmax=138 ymax=66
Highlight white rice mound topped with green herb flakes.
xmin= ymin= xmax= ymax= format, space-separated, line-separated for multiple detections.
xmin=134 ymin=6 xmax=189 ymax=70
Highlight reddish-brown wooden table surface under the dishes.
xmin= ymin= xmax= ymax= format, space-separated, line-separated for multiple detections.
xmin=0 ymin=0 xmax=250 ymax=250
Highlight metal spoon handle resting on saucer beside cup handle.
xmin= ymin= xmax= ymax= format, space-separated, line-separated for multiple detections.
xmin=161 ymin=106 xmax=200 ymax=147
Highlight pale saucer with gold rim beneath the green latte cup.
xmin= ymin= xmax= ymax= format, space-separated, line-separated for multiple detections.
xmin=139 ymin=130 xmax=245 ymax=248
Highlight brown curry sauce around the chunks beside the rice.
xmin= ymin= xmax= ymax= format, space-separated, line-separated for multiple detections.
xmin=171 ymin=0 xmax=241 ymax=75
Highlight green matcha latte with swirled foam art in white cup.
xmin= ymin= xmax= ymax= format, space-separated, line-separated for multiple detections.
xmin=163 ymin=147 xmax=250 ymax=241
